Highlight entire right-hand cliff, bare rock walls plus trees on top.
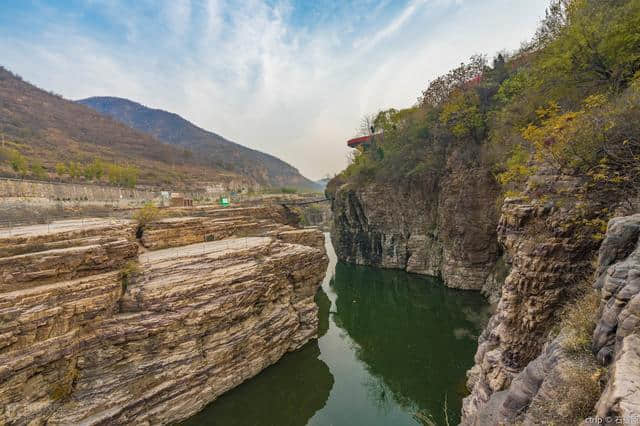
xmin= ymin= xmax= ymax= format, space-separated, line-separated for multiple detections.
xmin=326 ymin=0 xmax=640 ymax=426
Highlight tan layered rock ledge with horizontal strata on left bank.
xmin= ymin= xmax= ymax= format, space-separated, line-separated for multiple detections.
xmin=0 ymin=211 xmax=327 ymax=424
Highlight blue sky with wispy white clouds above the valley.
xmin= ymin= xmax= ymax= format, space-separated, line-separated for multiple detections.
xmin=0 ymin=0 xmax=548 ymax=179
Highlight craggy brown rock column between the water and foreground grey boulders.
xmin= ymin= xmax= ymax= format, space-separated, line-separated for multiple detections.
xmin=463 ymin=194 xmax=598 ymax=424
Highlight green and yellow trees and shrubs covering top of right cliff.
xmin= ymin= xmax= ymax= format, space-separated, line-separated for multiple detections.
xmin=336 ymin=0 xmax=640 ymax=197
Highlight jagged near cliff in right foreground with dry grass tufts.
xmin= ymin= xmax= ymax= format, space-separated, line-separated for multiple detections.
xmin=463 ymin=209 xmax=640 ymax=425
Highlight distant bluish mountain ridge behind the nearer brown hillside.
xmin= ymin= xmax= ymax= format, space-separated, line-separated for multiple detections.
xmin=77 ymin=97 xmax=321 ymax=190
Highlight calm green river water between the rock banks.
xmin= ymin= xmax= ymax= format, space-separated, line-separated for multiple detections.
xmin=183 ymin=238 xmax=489 ymax=426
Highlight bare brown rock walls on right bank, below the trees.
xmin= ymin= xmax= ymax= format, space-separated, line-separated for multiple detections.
xmin=328 ymin=167 xmax=640 ymax=426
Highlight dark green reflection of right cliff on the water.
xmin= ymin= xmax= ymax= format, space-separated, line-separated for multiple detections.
xmin=331 ymin=263 xmax=489 ymax=424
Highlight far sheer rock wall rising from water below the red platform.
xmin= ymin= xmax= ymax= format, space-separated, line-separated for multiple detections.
xmin=331 ymin=163 xmax=499 ymax=290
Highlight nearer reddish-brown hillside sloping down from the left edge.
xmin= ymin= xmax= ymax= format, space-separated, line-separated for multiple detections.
xmin=0 ymin=66 xmax=245 ymax=187
